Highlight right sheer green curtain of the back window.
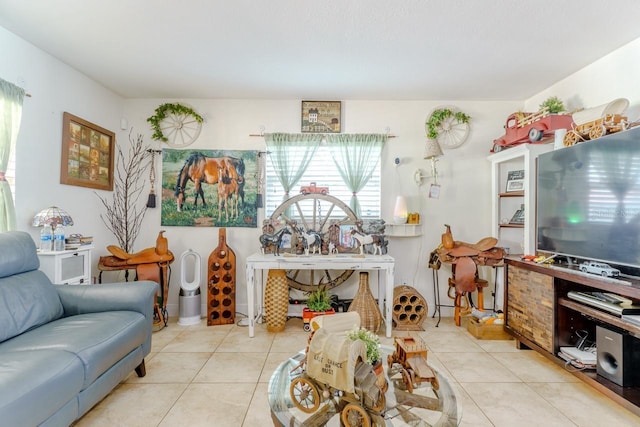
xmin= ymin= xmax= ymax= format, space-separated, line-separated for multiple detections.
xmin=327 ymin=134 xmax=387 ymax=218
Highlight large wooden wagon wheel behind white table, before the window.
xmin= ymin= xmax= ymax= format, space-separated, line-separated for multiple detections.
xmin=271 ymin=193 xmax=358 ymax=292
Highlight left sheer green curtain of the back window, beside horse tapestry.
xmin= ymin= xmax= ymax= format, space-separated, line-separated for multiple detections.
xmin=264 ymin=133 xmax=322 ymax=209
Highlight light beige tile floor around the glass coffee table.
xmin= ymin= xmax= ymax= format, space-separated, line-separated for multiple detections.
xmin=75 ymin=318 xmax=640 ymax=427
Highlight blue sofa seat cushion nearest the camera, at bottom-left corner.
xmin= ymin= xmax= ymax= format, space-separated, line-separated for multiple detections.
xmin=0 ymin=350 xmax=84 ymax=426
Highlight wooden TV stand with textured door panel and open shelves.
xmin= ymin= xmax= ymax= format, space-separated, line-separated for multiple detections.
xmin=504 ymin=257 xmax=640 ymax=415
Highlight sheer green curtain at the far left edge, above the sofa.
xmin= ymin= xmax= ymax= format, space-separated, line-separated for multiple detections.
xmin=0 ymin=79 xmax=24 ymax=232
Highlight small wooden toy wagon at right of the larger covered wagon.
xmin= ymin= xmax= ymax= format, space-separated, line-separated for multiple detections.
xmin=387 ymin=337 xmax=440 ymax=393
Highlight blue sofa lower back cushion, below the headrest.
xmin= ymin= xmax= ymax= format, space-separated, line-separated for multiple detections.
xmin=0 ymin=270 xmax=64 ymax=342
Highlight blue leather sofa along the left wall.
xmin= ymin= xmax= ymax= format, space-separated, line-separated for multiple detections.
xmin=0 ymin=231 xmax=158 ymax=427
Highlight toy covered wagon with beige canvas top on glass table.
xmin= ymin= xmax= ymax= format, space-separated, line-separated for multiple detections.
xmin=289 ymin=316 xmax=386 ymax=427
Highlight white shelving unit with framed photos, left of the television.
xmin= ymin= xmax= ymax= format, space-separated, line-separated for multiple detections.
xmin=488 ymin=144 xmax=553 ymax=255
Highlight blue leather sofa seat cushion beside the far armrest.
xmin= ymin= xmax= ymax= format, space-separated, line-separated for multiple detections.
xmin=0 ymin=311 xmax=148 ymax=389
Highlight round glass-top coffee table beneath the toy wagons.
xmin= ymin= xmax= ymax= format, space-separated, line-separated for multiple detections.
xmin=268 ymin=346 xmax=462 ymax=427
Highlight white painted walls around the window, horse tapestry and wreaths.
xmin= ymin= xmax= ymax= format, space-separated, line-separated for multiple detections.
xmin=7 ymin=21 xmax=640 ymax=315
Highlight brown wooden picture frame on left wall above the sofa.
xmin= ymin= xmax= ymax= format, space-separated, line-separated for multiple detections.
xmin=60 ymin=111 xmax=116 ymax=191
